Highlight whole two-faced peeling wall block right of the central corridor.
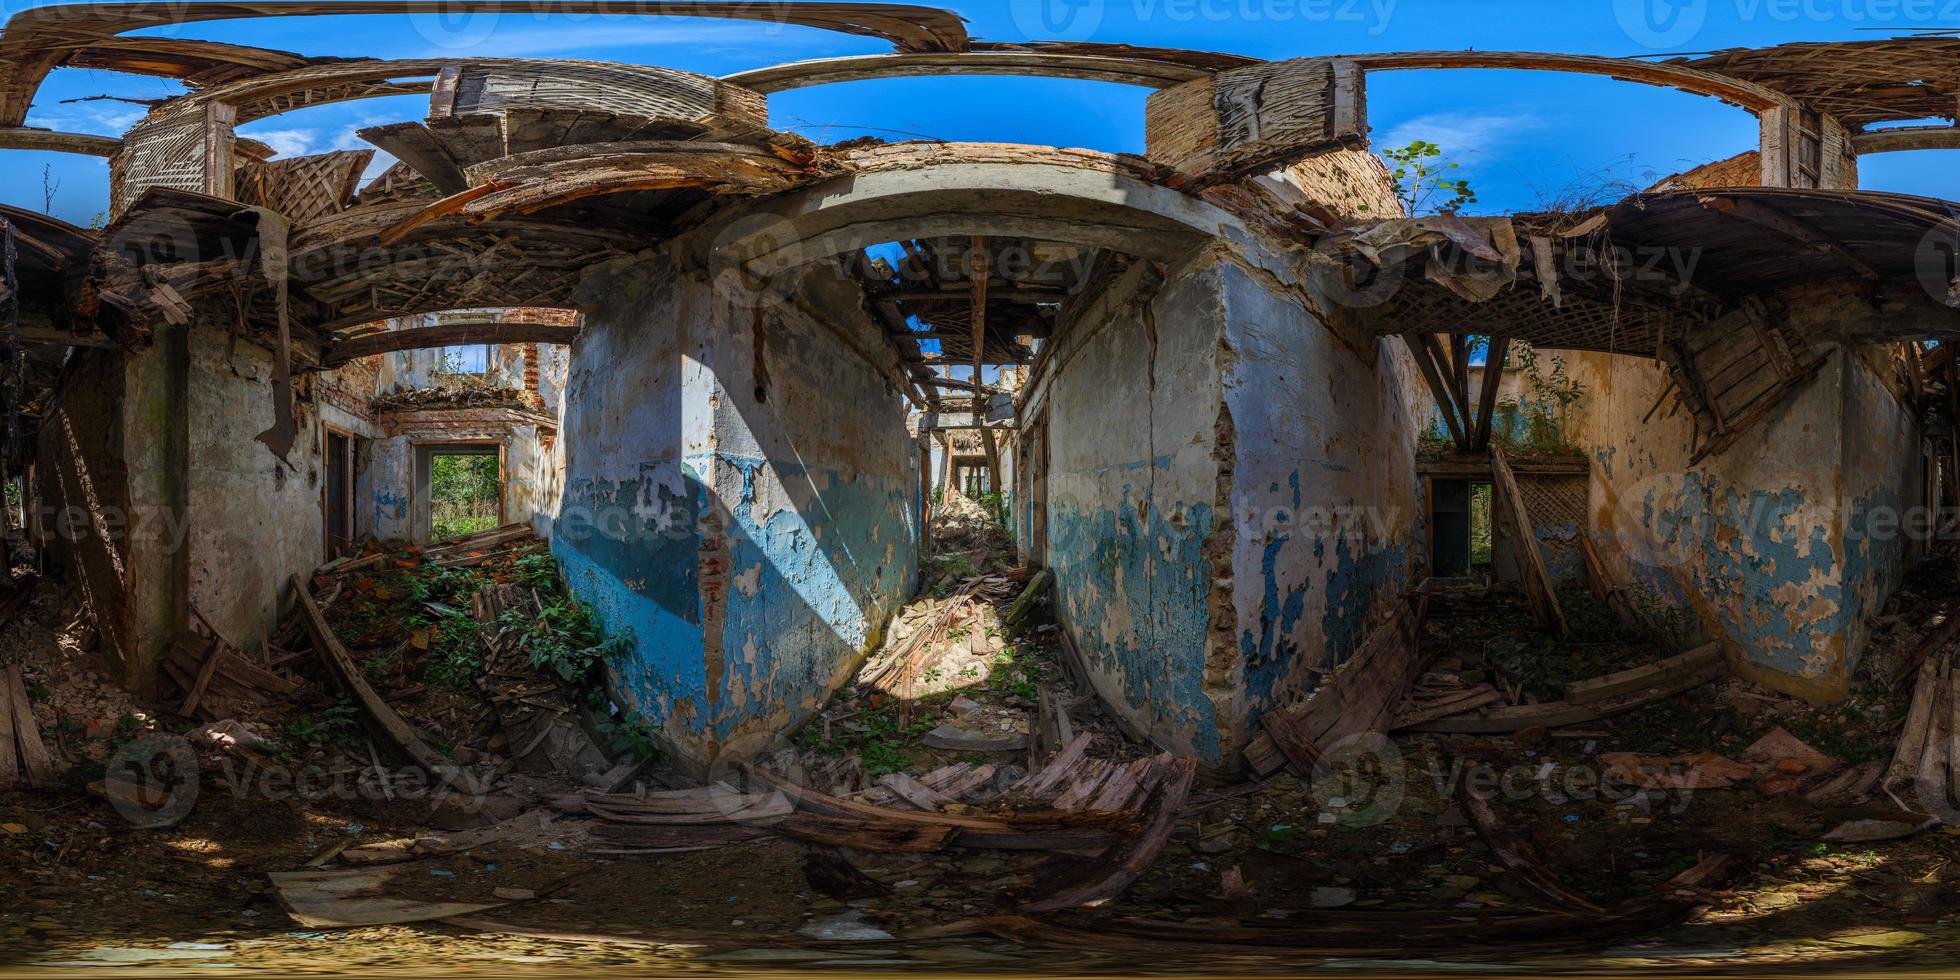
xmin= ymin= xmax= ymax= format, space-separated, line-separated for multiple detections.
xmin=1025 ymin=249 xmax=1427 ymax=768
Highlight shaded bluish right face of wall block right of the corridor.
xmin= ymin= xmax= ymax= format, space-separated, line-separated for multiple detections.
xmin=1221 ymin=265 xmax=1435 ymax=748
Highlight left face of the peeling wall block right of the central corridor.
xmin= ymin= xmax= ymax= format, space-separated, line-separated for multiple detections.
xmin=1045 ymin=259 xmax=1239 ymax=766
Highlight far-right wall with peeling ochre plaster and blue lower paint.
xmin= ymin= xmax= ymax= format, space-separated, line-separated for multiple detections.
xmin=1570 ymin=345 xmax=1925 ymax=702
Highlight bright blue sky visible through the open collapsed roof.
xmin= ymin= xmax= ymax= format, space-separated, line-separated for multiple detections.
xmin=0 ymin=0 xmax=1960 ymax=223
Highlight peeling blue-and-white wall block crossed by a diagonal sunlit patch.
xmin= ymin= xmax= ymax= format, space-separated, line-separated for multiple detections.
xmin=553 ymin=257 xmax=919 ymax=766
